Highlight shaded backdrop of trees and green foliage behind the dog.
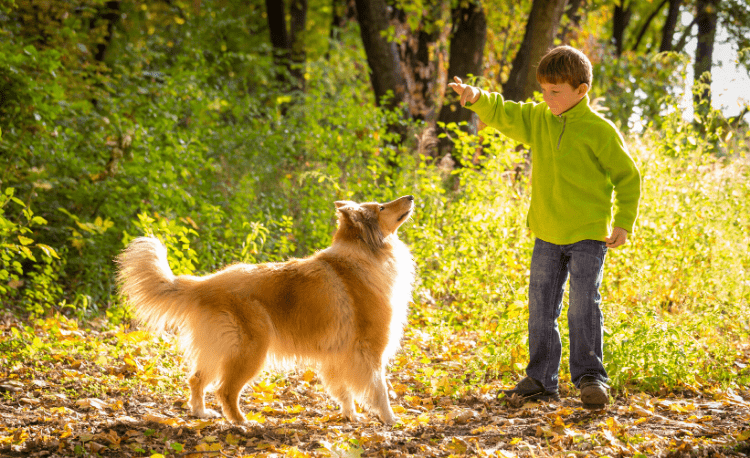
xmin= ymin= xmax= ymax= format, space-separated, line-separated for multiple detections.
xmin=0 ymin=0 xmax=750 ymax=310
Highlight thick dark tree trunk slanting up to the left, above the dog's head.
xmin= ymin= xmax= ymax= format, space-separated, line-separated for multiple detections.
xmin=356 ymin=0 xmax=406 ymax=109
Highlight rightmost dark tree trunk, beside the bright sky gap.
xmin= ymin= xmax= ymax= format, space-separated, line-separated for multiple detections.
xmin=693 ymin=0 xmax=720 ymax=113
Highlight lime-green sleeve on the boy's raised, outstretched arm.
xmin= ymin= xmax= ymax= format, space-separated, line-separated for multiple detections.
xmin=466 ymin=90 xmax=537 ymax=145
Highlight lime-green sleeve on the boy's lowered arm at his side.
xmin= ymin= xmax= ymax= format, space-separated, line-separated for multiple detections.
xmin=599 ymin=131 xmax=641 ymax=233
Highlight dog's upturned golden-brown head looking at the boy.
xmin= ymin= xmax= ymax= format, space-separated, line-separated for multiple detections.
xmin=333 ymin=196 xmax=414 ymax=250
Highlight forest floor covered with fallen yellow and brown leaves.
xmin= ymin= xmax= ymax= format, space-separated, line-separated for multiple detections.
xmin=0 ymin=316 xmax=750 ymax=458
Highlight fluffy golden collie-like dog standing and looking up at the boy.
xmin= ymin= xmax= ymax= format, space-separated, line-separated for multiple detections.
xmin=117 ymin=196 xmax=415 ymax=425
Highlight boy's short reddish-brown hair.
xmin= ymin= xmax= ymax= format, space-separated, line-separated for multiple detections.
xmin=536 ymin=46 xmax=593 ymax=89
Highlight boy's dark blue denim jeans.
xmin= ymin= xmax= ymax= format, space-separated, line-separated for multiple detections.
xmin=526 ymin=239 xmax=609 ymax=391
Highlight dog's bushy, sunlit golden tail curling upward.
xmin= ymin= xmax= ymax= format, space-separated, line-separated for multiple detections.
xmin=117 ymin=237 xmax=198 ymax=330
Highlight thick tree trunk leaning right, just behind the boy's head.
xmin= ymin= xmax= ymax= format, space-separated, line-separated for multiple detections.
xmin=503 ymin=0 xmax=565 ymax=101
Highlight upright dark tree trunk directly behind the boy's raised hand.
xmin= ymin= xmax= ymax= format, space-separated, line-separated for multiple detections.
xmin=438 ymin=2 xmax=487 ymax=158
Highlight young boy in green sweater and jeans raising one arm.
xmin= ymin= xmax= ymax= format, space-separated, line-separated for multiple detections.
xmin=449 ymin=46 xmax=640 ymax=409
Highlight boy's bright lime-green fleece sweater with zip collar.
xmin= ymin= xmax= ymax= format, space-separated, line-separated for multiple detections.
xmin=466 ymin=91 xmax=641 ymax=245
